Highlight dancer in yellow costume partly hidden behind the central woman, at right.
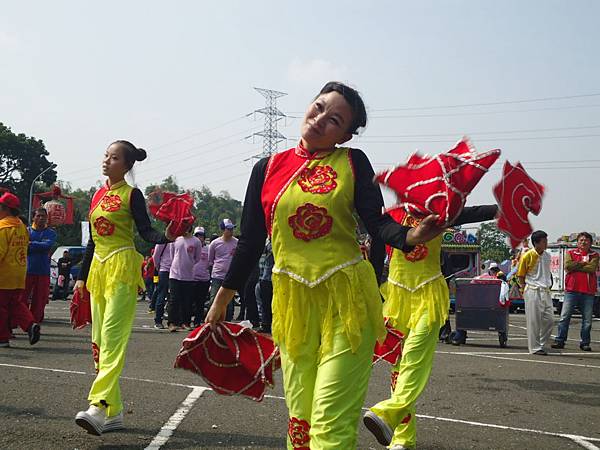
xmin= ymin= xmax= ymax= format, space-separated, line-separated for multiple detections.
xmin=363 ymin=205 xmax=498 ymax=450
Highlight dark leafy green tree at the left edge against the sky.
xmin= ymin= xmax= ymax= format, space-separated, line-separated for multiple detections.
xmin=0 ymin=122 xmax=56 ymax=212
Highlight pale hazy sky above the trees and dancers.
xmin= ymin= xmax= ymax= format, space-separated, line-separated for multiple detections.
xmin=0 ymin=0 xmax=600 ymax=239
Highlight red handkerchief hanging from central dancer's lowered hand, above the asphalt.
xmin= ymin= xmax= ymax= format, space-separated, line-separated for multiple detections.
xmin=175 ymin=322 xmax=281 ymax=401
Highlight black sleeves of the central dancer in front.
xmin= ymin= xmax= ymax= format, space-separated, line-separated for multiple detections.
xmin=223 ymin=149 xmax=411 ymax=290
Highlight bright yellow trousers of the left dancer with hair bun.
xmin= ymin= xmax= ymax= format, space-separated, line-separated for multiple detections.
xmin=88 ymin=284 xmax=137 ymax=417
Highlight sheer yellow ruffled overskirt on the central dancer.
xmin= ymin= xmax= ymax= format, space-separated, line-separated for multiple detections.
xmin=272 ymin=261 xmax=386 ymax=359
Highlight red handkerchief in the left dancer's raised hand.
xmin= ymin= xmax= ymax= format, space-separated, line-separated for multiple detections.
xmin=148 ymin=191 xmax=195 ymax=236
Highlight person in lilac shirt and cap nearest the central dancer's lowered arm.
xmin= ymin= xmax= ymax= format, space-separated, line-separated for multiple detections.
xmin=208 ymin=219 xmax=238 ymax=321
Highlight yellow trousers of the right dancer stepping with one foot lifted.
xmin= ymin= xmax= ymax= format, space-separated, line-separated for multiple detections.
xmin=370 ymin=312 xmax=442 ymax=447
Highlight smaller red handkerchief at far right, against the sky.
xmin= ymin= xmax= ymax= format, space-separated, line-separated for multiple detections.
xmin=494 ymin=161 xmax=544 ymax=248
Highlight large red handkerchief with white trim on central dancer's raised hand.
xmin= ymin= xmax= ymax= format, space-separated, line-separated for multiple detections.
xmin=375 ymin=138 xmax=500 ymax=227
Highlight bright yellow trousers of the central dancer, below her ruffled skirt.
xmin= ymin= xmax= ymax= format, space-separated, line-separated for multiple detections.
xmin=280 ymin=315 xmax=375 ymax=450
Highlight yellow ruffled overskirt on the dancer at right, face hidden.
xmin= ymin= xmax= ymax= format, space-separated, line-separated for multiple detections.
xmin=381 ymin=276 xmax=450 ymax=334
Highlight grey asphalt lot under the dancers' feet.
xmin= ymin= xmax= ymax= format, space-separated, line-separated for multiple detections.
xmin=0 ymin=301 xmax=600 ymax=450
